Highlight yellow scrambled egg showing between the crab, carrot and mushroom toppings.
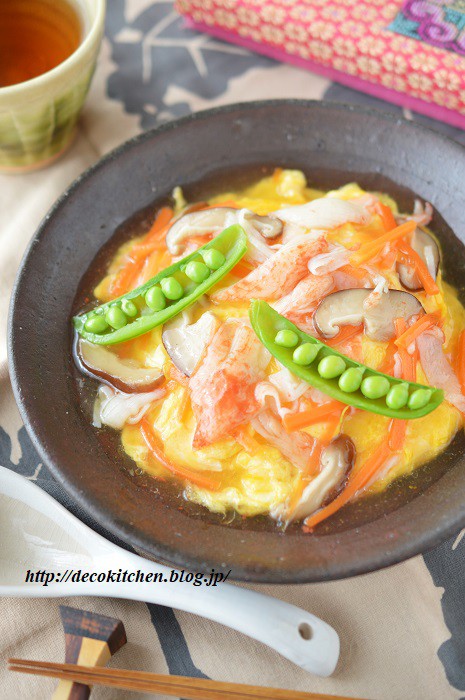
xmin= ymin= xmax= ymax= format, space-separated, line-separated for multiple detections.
xmin=95 ymin=169 xmax=465 ymax=516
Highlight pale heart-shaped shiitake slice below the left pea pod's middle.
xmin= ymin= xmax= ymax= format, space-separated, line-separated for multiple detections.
xmin=161 ymin=311 xmax=219 ymax=377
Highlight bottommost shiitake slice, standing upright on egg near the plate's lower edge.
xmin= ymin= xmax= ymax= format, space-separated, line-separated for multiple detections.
xmin=289 ymin=434 xmax=355 ymax=520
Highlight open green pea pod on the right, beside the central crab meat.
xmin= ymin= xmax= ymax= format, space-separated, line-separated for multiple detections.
xmin=249 ymin=301 xmax=444 ymax=419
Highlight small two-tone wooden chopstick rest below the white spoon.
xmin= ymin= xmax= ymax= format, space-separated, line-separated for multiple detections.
xmin=53 ymin=605 xmax=127 ymax=700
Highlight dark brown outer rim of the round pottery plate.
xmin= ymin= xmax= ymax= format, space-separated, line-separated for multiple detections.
xmin=8 ymin=99 xmax=465 ymax=583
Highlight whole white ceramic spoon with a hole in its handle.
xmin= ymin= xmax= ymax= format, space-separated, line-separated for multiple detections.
xmin=0 ymin=467 xmax=339 ymax=676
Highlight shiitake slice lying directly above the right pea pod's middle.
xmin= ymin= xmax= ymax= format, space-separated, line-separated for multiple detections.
xmin=313 ymin=289 xmax=425 ymax=341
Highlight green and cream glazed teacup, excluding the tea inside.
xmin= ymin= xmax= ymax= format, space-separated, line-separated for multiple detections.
xmin=0 ymin=0 xmax=106 ymax=173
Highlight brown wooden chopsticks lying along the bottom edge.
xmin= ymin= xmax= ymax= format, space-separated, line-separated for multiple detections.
xmin=8 ymin=659 xmax=362 ymax=700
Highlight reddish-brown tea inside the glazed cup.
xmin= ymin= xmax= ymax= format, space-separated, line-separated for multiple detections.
xmin=0 ymin=0 xmax=82 ymax=87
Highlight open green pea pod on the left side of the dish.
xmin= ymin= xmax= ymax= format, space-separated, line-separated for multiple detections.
xmin=73 ymin=224 xmax=247 ymax=345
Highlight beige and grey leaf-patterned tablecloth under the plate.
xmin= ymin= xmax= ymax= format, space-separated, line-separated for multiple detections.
xmin=0 ymin=0 xmax=465 ymax=700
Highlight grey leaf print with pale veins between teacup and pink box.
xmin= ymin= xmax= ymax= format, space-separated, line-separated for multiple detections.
xmin=106 ymin=0 xmax=276 ymax=129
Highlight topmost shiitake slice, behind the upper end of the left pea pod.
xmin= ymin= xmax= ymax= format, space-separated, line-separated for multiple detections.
xmin=166 ymin=207 xmax=283 ymax=255
